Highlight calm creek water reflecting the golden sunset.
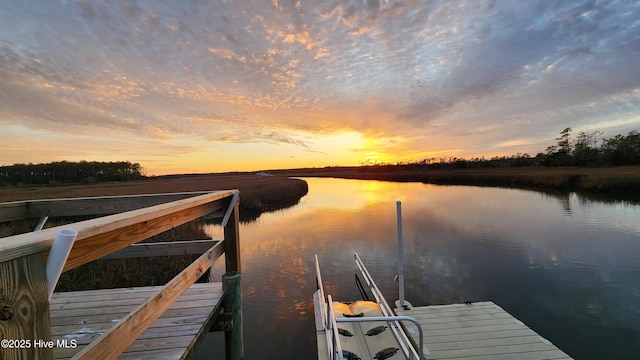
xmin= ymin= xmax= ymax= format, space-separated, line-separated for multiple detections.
xmin=197 ymin=178 xmax=640 ymax=359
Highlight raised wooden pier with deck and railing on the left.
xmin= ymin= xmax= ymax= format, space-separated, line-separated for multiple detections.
xmin=0 ymin=190 xmax=244 ymax=359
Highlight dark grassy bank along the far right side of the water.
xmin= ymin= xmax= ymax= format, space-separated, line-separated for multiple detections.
xmin=282 ymin=166 xmax=640 ymax=198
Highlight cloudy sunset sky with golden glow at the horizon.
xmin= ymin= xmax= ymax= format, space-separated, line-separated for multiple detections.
xmin=0 ymin=0 xmax=640 ymax=175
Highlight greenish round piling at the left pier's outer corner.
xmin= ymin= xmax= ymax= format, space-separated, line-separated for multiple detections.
xmin=222 ymin=272 xmax=244 ymax=360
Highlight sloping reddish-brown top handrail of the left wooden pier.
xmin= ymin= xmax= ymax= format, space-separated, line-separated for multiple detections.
xmin=0 ymin=190 xmax=234 ymax=264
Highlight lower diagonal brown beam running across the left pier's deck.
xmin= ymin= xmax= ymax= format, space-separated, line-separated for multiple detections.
xmin=73 ymin=242 xmax=224 ymax=359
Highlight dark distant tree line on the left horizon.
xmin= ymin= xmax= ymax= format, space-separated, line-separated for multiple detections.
xmin=0 ymin=161 xmax=144 ymax=186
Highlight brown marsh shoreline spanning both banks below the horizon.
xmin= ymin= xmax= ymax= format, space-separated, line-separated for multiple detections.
xmin=0 ymin=165 xmax=640 ymax=211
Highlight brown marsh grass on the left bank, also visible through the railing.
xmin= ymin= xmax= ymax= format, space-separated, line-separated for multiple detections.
xmin=0 ymin=175 xmax=308 ymax=291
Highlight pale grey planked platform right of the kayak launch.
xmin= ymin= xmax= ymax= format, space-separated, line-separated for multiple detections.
xmin=394 ymin=301 xmax=571 ymax=360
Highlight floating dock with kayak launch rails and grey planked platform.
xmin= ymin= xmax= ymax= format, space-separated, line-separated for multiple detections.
xmin=313 ymin=254 xmax=571 ymax=360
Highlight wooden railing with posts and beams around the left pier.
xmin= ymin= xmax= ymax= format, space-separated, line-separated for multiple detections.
xmin=0 ymin=190 xmax=243 ymax=359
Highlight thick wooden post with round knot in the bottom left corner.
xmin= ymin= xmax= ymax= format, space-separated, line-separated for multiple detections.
xmin=0 ymin=252 xmax=53 ymax=360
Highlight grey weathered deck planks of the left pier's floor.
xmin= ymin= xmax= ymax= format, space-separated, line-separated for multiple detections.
xmin=51 ymin=283 xmax=223 ymax=359
